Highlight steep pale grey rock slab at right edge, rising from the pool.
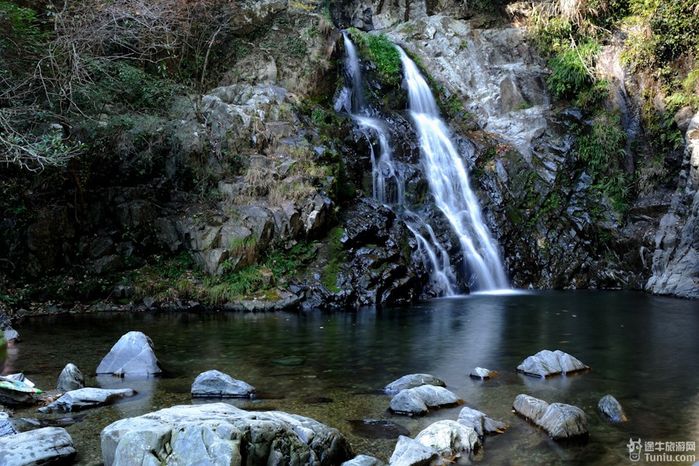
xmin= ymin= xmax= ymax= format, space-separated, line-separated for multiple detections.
xmin=646 ymin=113 xmax=699 ymax=298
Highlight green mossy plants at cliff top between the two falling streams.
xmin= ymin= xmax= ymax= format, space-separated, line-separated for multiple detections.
xmin=349 ymin=28 xmax=403 ymax=87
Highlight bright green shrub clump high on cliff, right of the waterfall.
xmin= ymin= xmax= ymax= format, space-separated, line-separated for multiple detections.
xmin=546 ymin=41 xmax=600 ymax=98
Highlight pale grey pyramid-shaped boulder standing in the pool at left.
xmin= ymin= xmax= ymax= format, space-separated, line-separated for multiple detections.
xmin=97 ymin=332 xmax=162 ymax=376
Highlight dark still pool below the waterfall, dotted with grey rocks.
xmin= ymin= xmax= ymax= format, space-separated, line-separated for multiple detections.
xmin=5 ymin=292 xmax=699 ymax=465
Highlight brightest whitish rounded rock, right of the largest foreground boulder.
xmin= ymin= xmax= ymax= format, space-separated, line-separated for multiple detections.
xmin=415 ymin=420 xmax=480 ymax=460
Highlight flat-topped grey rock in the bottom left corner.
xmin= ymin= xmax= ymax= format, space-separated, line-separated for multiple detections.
xmin=0 ymin=427 xmax=75 ymax=466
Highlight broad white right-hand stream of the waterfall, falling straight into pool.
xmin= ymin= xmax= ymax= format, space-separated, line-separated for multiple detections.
xmin=398 ymin=47 xmax=509 ymax=290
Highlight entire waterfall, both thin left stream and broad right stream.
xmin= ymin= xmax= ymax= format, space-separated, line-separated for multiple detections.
xmin=335 ymin=33 xmax=509 ymax=296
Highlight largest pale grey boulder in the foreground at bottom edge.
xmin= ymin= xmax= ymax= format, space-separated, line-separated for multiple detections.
xmin=100 ymin=403 xmax=354 ymax=466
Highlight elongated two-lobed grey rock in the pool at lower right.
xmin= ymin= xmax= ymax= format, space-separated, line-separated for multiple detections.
xmin=513 ymin=395 xmax=588 ymax=440
